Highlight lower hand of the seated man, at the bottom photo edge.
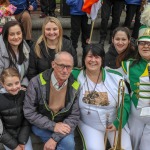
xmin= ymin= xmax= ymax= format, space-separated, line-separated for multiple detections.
xmin=43 ymin=138 xmax=57 ymax=150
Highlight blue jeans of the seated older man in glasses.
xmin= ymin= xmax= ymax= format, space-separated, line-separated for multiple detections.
xmin=32 ymin=126 xmax=75 ymax=150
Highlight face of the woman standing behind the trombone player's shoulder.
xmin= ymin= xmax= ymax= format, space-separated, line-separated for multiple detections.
xmin=112 ymin=31 xmax=130 ymax=54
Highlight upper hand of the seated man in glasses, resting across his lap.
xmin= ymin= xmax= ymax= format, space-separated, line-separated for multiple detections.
xmin=54 ymin=122 xmax=71 ymax=135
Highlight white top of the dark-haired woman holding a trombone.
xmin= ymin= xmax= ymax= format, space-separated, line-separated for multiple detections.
xmin=79 ymin=72 xmax=117 ymax=130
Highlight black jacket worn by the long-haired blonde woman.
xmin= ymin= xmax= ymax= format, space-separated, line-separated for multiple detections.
xmin=27 ymin=38 xmax=77 ymax=80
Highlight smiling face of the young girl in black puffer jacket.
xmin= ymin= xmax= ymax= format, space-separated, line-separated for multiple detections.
xmin=2 ymin=76 xmax=21 ymax=95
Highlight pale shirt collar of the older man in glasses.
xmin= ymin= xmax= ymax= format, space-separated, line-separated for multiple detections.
xmin=51 ymin=72 xmax=68 ymax=91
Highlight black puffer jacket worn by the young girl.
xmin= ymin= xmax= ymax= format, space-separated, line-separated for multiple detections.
xmin=0 ymin=91 xmax=30 ymax=149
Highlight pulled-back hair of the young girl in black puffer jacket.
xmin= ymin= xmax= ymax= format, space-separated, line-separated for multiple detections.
xmin=0 ymin=67 xmax=21 ymax=83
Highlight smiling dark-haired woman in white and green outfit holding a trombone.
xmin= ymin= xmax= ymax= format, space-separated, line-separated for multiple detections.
xmin=72 ymin=44 xmax=132 ymax=150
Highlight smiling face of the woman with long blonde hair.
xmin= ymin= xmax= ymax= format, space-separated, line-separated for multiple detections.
xmin=45 ymin=22 xmax=59 ymax=41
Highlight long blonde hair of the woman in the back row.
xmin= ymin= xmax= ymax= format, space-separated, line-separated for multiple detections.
xmin=35 ymin=17 xmax=63 ymax=58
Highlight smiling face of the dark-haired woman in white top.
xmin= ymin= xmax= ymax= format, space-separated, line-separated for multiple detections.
xmin=85 ymin=51 xmax=102 ymax=72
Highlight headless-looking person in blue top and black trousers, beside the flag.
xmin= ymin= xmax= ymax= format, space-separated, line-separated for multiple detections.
xmin=66 ymin=0 xmax=91 ymax=62
